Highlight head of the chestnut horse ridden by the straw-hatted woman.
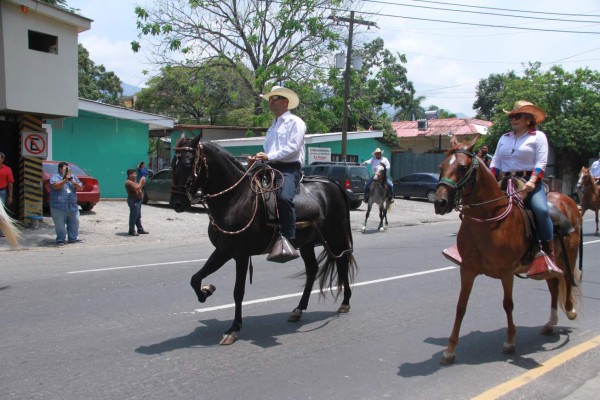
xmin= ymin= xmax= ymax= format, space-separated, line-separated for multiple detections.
xmin=434 ymin=138 xmax=479 ymax=214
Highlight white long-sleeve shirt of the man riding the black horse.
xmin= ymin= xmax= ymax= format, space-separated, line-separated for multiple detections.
xmin=263 ymin=111 xmax=306 ymax=165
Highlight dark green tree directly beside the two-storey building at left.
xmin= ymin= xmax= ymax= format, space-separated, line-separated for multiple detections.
xmin=78 ymin=44 xmax=123 ymax=105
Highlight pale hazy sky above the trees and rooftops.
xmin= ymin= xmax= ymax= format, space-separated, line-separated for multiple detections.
xmin=67 ymin=0 xmax=600 ymax=117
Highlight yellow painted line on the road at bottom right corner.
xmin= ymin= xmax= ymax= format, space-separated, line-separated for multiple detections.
xmin=472 ymin=336 xmax=600 ymax=400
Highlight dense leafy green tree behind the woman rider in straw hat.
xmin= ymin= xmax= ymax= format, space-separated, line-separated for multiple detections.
xmin=478 ymin=62 xmax=600 ymax=177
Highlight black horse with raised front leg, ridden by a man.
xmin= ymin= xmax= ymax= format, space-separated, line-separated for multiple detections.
xmin=170 ymin=136 xmax=357 ymax=344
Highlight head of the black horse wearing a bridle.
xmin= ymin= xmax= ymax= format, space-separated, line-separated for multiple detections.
xmin=169 ymin=136 xmax=203 ymax=212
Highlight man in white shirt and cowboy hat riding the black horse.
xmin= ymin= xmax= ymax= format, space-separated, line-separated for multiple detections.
xmin=250 ymin=86 xmax=306 ymax=240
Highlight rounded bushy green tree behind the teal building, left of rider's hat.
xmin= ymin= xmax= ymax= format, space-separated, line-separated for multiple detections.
xmin=136 ymin=60 xmax=254 ymax=125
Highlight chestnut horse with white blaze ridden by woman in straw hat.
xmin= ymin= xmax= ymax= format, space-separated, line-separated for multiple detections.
xmin=435 ymin=139 xmax=582 ymax=364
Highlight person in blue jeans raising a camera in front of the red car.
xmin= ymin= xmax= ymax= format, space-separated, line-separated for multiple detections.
xmin=50 ymin=162 xmax=83 ymax=246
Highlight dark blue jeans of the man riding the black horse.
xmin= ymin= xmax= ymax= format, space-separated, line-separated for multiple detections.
xmin=273 ymin=165 xmax=302 ymax=240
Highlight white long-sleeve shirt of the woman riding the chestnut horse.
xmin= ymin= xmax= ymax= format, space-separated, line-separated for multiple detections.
xmin=490 ymin=130 xmax=548 ymax=178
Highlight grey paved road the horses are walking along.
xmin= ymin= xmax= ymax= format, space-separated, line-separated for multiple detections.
xmin=0 ymin=214 xmax=600 ymax=400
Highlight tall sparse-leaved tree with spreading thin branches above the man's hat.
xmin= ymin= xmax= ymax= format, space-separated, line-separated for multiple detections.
xmin=132 ymin=0 xmax=354 ymax=119
